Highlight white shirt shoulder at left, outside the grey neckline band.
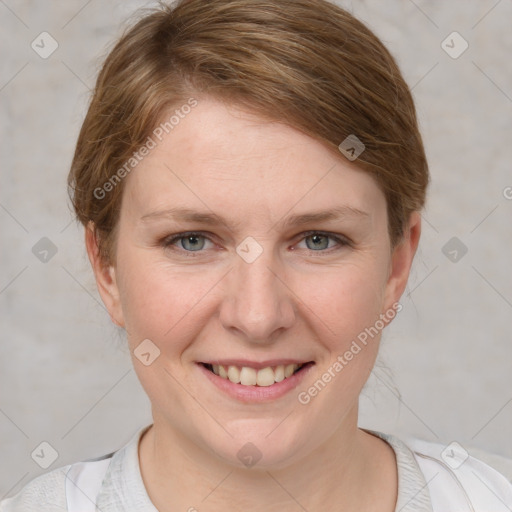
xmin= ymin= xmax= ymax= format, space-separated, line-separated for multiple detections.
xmin=0 ymin=454 xmax=113 ymax=512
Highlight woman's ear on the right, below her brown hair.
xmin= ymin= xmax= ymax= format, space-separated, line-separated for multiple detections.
xmin=384 ymin=212 xmax=421 ymax=312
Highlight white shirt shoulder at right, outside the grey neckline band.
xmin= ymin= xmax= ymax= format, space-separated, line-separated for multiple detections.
xmin=404 ymin=438 xmax=512 ymax=512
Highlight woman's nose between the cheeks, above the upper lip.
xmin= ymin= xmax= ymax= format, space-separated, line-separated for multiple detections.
xmin=220 ymin=244 xmax=295 ymax=344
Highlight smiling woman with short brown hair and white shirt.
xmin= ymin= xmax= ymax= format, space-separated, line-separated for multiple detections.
xmin=0 ymin=0 xmax=512 ymax=512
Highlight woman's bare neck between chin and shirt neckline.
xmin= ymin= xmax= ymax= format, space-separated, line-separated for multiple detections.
xmin=139 ymin=408 xmax=397 ymax=512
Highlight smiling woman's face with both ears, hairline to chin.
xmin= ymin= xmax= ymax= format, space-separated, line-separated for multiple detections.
xmin=87 ymin=99 xmax=420 ymax=467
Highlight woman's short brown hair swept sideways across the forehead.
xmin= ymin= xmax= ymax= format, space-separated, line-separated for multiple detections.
xmin=68 ymin=0 xmax=429 ymax=264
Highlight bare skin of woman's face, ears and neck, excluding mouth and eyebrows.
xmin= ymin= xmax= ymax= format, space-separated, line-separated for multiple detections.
xmin=86 ymin=97 xmax=421 ymax=512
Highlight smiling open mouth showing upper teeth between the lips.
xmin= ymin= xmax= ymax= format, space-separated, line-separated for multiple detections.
xmin=199 ymin=361 xmax=315 ymax=387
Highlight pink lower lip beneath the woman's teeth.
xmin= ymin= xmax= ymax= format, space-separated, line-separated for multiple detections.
xmin=197 ymin=363 xmax=314 ymax=402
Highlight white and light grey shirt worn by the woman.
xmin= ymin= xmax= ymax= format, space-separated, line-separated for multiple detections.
xmin=0 ymin=425 xmax=512 ymax=512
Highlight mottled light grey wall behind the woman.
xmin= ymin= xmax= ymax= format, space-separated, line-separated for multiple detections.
xmin=0 ymin=0 xmax=512 ymax=498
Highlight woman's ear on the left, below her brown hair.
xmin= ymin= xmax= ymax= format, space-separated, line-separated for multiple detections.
xmin=85 ymin=221 xmax=125 ymax=328
